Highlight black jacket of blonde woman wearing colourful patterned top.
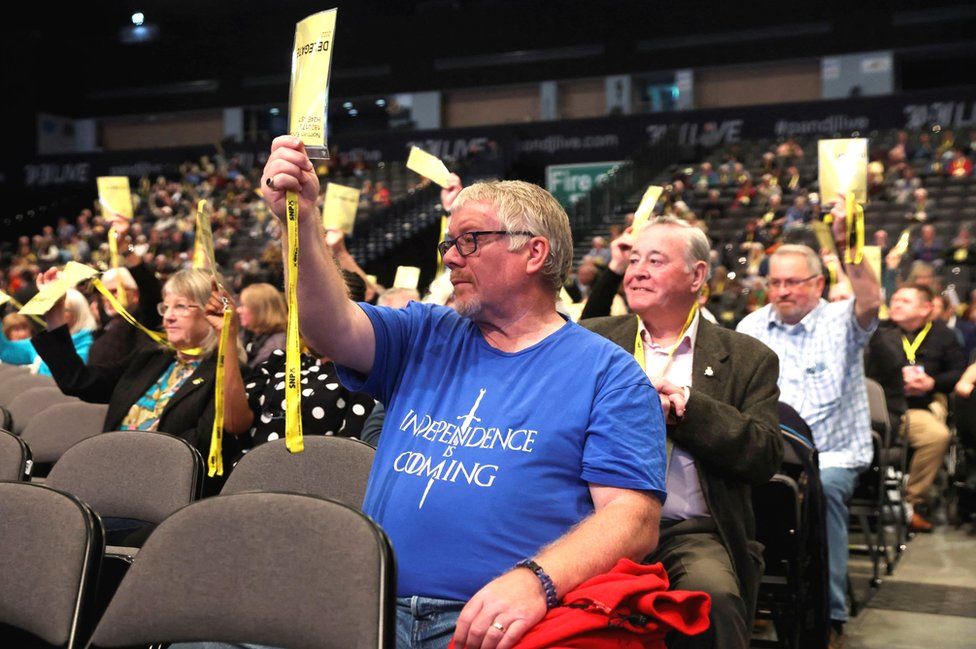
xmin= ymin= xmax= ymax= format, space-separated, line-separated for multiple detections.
xmin=32 ymin=326 xmax=236 ymax=491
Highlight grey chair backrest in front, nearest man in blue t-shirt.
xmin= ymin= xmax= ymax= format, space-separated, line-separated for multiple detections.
xmin=92 ymin=493 xmax=396 ymax=649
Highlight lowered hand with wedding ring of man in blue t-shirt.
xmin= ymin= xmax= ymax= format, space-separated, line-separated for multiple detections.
xmin=454 ymin=568 xmax=547 ymax=649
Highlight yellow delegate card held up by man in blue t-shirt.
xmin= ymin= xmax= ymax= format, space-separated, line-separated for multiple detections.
xmin=288 ymin=9 xmax=338 ymax=160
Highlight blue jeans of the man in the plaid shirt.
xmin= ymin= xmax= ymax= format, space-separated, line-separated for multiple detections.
xmin=820 ymin=467 xmax=859 ymax=622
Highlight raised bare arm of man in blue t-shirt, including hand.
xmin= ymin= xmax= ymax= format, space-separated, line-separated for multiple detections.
xmin=261 ymin=135 xmax=376 ymax=373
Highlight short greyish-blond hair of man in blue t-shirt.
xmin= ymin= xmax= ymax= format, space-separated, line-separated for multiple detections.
xmin=451 ymin=180 xmax=573 ymax=294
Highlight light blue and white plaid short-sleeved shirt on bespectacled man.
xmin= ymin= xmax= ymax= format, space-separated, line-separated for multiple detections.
xmin=736 ymin=300 xmax=878 ymax=469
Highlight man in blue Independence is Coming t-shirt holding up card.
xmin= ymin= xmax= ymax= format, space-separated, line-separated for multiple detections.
xmin=263 ymin=136 xmax=665 ymax=648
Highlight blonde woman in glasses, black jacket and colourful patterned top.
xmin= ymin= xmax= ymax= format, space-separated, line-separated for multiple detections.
xmin=33 ymin=269 xmax=254 ymax=493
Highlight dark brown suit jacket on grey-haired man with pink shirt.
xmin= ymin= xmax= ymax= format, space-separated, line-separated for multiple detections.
xmin=580 ymin=315 xmax=783 ymax=610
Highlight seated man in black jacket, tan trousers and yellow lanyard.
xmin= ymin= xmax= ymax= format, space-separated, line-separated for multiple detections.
xmin=884 ymin=284 xmax=966 ymax=532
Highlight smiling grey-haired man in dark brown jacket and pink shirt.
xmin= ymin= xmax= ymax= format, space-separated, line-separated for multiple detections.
xmin=580 ymin=217 xmax=783 ymax=648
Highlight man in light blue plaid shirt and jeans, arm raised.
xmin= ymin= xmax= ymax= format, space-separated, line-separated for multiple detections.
xmin=736 ymin=240 xmax=881 ymax=644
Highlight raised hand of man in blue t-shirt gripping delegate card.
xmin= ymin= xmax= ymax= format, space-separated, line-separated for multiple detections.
xmin=261 ymin=135 xmax=319 ymax=221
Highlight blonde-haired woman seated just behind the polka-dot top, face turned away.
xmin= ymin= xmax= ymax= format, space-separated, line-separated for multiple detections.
xmin=237 ymin=283 xmax=288 ymax=369
